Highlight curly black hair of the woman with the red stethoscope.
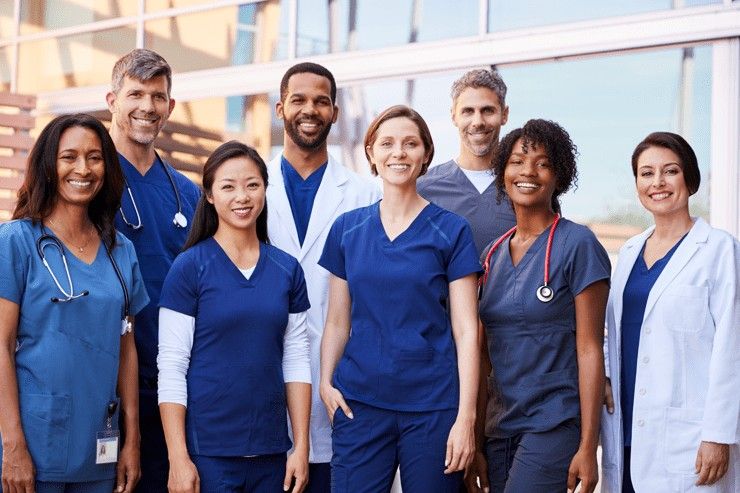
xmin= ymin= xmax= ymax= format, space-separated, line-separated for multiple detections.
xmin=491 ymin=119 xmax=578 ymax=213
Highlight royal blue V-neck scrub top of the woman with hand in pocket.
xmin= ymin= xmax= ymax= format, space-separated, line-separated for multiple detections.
xmin=319 ymin=202 xmax=480 ymax=411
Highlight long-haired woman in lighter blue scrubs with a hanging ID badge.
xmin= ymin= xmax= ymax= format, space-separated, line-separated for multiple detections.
xmin=0 ymin=115 xmax=149 ymax=493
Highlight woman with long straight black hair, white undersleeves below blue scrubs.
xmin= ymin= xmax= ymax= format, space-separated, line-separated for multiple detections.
xmin=157 ymin=141 xmax=311 ymax=493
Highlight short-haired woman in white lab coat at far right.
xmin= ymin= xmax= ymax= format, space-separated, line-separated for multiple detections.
xmin=601 ymin=132 xmax=740 ymax=493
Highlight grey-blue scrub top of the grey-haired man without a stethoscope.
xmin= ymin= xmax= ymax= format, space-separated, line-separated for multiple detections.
xmin=416 ymin=161 xmax=516 ymax=253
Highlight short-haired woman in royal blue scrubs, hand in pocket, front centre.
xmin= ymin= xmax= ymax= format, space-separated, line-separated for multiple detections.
xmin=319 ymin=106 xmax=480 ymax=493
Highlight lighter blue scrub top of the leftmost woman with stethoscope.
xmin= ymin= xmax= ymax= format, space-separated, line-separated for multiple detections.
xmin=0 ymin=219 xmax=149 ymax=482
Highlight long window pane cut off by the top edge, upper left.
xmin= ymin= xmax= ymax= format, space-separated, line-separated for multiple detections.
xmin=20 ymin=0 xmax=138 ymax=34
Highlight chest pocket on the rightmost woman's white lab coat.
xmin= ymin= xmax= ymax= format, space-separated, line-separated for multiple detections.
xmin=663 ymin=284 xmax=709 ymax=332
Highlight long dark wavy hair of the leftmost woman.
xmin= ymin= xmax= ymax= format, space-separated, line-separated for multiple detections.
xmin=13 ymin=113 xmax=124 ymax=248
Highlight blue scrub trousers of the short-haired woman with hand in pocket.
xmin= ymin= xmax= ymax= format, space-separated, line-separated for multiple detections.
xmin=331 ymin=400 xmax=463 ymax=493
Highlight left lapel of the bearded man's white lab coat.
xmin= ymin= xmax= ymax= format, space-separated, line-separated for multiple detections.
xmin=267 ymin=154 xmax=301 ymax=257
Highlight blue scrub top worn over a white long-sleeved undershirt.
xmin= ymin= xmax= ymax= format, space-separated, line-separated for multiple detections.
xmin=160 ymin=237 xmax=310 ymax=457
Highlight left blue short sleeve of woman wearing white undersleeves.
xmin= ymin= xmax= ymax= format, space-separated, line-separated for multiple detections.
xmin=159 ymin=250 xmax=198 ymax=317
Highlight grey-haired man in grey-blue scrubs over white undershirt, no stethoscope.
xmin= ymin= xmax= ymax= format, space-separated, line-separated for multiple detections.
xmin=417 ymin=69 xmax=516 ymax=254
